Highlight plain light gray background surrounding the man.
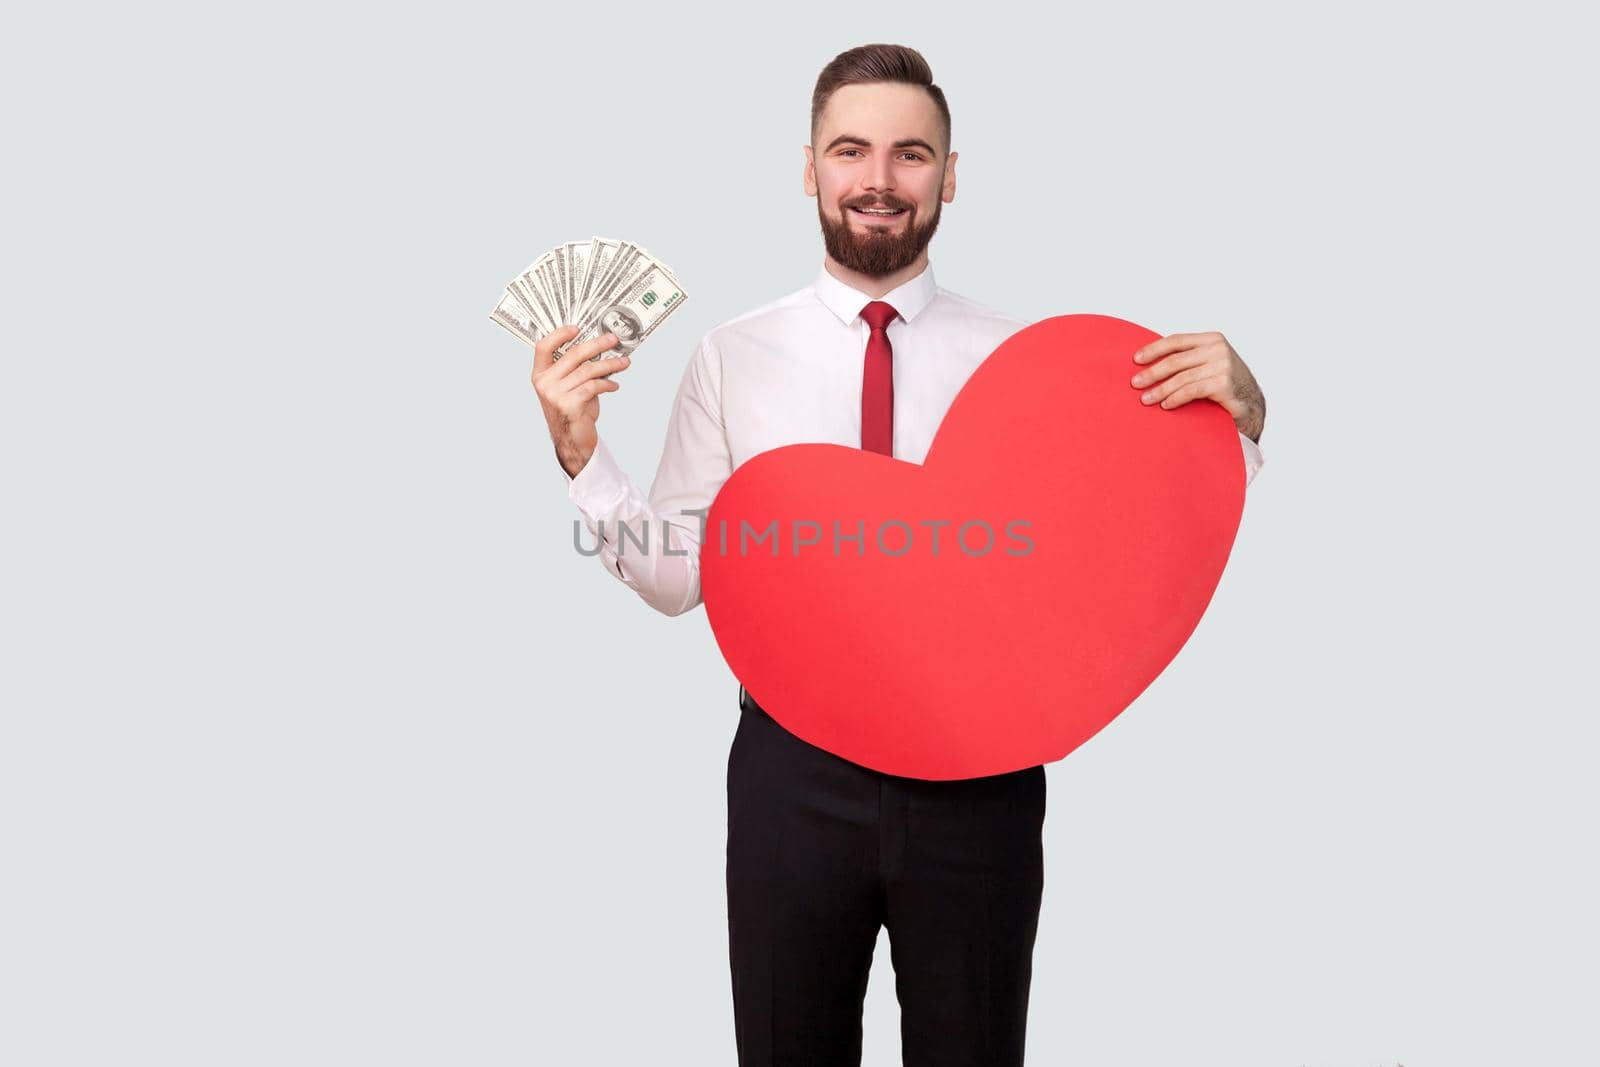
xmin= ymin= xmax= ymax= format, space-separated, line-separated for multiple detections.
xmin=0 ymin=3 xmax=1600 ymax=1067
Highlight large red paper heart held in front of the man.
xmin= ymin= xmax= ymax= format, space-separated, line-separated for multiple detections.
xmin=701 ymin=315 xmax=1245 ymax=779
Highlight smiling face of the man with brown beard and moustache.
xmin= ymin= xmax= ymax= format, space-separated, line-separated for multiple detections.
xmin=805 ymin=82 xmax=958 ymax=278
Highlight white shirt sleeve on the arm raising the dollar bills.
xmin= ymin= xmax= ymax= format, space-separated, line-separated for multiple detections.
xmin=566 ymin=339 xmax=733 ymax=616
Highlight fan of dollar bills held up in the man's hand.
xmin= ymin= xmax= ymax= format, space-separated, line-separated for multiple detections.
xmin=490 ymin=237 xmax=688 ymax=360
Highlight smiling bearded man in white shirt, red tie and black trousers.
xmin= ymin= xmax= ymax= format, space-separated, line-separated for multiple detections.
xmin=533 ymin=45 xmax=1266 ymax=1067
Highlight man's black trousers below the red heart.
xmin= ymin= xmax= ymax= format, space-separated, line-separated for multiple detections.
xmin=728 ymin=686 xmax=1045 ymax=1067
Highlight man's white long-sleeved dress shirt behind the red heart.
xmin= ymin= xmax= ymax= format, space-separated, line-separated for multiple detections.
xmin=566 ymin=264 xmax=1266 ymax=616
